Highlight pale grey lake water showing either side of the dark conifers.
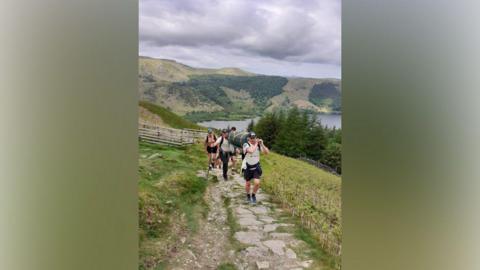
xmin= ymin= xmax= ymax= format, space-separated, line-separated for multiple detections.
xmin=197 ymin=114 xmax=342 ymax=131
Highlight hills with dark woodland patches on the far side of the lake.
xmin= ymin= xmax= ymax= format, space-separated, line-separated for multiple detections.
xmin=138 ymin=57 xmax=341 ymax=121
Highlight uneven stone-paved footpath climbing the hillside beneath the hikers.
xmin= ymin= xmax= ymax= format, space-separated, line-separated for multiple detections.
xmin=172 ymin=169 xmax=319 ymax=270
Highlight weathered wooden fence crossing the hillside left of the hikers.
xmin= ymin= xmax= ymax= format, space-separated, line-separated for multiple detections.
xmin=138 ymin=122 xmax=207 ymax=146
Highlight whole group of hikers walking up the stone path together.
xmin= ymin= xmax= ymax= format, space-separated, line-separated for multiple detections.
xmin=205 ymin=127 xmax=269 ymax=204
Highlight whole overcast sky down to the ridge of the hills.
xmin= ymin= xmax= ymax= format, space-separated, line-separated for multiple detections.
xmin=139 ymin=0 xmax=341 ymax=78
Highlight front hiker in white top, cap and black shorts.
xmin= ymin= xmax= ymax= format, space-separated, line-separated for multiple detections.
xmin=242 ymin=132 xmax=270 ymax=204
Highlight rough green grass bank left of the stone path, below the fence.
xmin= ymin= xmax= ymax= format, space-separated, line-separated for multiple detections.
xmin=139 ymin=142 xmax=208 ymax=269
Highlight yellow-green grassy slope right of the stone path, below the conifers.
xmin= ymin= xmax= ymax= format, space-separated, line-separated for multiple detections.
xmin=262 ymin=153 xmax=342 ymax=269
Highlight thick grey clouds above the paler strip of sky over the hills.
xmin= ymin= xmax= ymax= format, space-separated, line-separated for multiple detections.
xmin=140 ymin=0 xmax=340 ymax=64
